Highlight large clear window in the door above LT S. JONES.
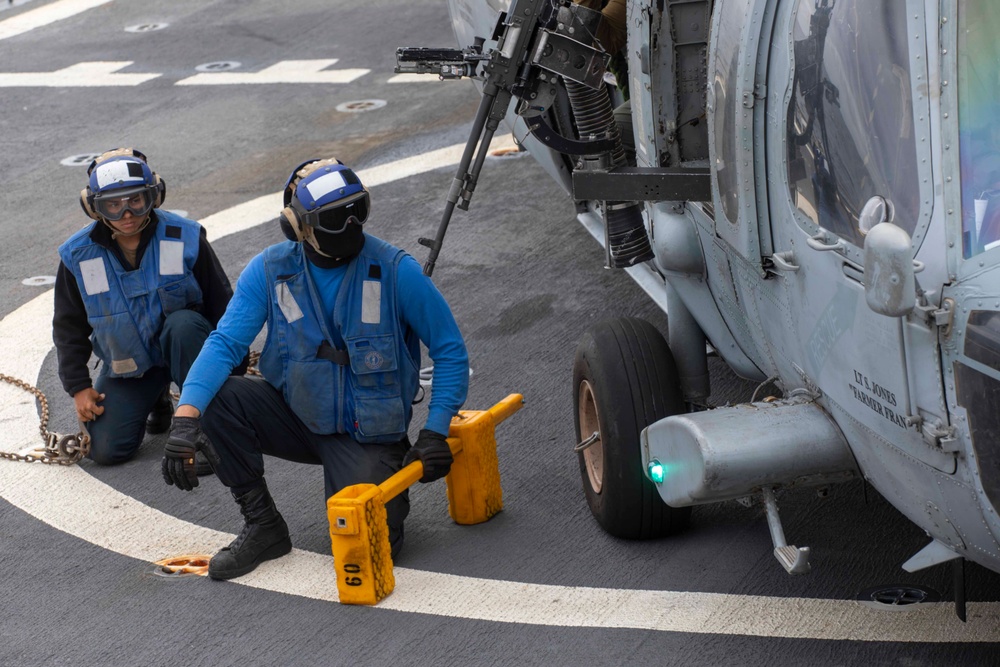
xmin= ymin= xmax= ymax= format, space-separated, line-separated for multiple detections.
xmin=787 ymin=0 xmax=916 ymax=246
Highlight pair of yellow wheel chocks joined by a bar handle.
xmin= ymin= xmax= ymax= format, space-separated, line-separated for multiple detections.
xmin=326 ymin=394 xmax=524 ymax=604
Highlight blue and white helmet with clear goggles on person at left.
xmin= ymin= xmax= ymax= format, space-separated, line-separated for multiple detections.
xmin=80 ymin=148 xmax=167 ymax=221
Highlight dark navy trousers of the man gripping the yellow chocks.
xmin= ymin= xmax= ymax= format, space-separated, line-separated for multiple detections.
xmin=201 ymin=377 xmax=410 ymax=554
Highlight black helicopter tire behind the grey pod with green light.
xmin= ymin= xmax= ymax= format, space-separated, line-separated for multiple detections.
xmin=573 ymin=317 xmax=691 ymax=539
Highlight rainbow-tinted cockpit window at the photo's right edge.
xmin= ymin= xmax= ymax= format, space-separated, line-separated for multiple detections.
xmin=958 ymin=0 xmax=1000 ymax=258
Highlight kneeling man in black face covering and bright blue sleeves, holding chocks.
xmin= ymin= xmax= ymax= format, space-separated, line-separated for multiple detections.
xmin=163 ymin=158 xmax=469 ymax=579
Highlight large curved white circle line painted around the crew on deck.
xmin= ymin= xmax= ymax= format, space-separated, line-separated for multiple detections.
xmin=0 ymin=140 xmax=1000 ymax=642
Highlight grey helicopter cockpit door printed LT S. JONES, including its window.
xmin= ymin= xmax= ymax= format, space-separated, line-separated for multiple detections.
xmin=767 ymin=0 xmax=955 ymax=478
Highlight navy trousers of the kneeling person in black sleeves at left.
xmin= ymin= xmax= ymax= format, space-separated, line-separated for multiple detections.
xmin=87 ymin=310 xmax=212 ymax=465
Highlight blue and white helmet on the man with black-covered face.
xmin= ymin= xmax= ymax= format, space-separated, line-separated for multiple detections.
xmin=278 ymin=158 xmax=371 ymax=254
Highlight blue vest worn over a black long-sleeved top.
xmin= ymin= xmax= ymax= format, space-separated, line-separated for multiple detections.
xmin=59 ymin=210 xmax=202 ymax=377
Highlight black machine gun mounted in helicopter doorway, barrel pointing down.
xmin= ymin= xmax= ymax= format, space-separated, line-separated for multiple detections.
xmin=395 ymin=0 xmax=620 ymax=276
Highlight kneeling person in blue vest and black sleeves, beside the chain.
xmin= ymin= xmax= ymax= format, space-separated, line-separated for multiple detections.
xmin=52 ymin=148 xmax=240 ymax=474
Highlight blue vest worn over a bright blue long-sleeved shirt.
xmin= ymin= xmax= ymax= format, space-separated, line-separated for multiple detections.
xmin=259 ymin=236 xmax=420 ymax=443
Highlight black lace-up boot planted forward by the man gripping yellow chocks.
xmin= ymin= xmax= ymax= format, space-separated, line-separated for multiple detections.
xmin=208 ymin=484 xmax=292 ymax=579
